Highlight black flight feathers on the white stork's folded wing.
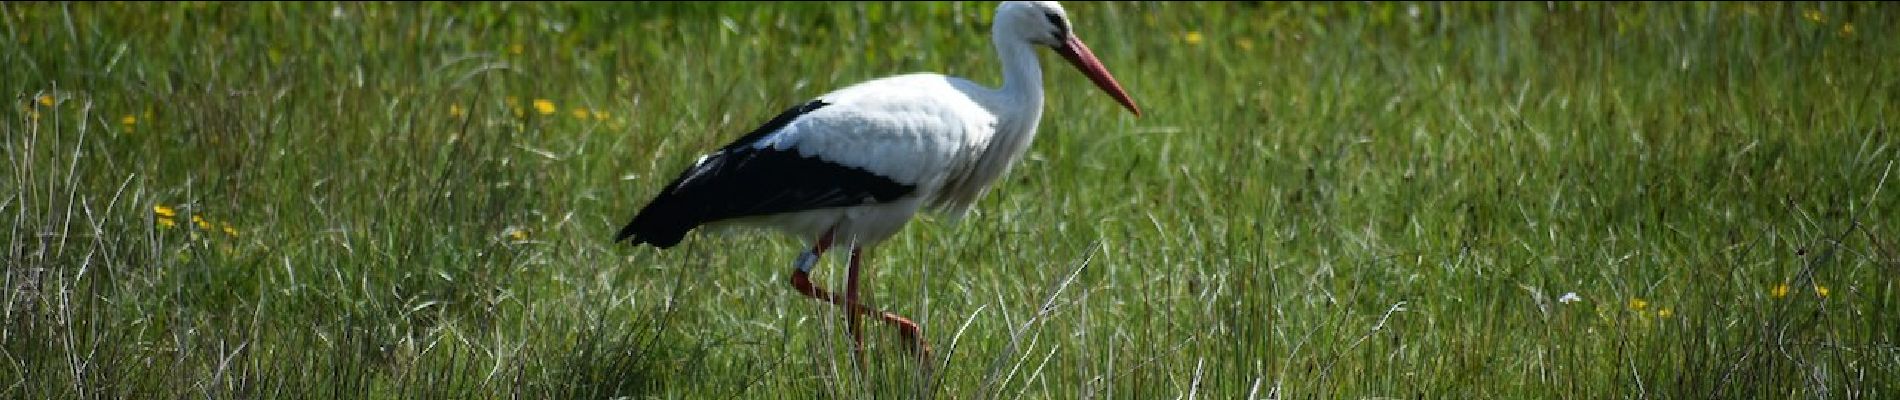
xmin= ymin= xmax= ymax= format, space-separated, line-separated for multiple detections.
xmin=614 ymin=100 xmax=916 ymax=248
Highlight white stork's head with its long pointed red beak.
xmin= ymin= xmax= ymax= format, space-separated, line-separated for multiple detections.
xmin=990 ymin=2 xmax=1142 ymax=116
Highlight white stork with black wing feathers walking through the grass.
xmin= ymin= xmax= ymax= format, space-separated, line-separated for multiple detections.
xmin=614 ymin=2 xmax=1142 ymax=356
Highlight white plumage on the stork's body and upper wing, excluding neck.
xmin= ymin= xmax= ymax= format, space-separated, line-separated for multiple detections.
xmin=737 ymin=74 xmax=1010 ymax=246
